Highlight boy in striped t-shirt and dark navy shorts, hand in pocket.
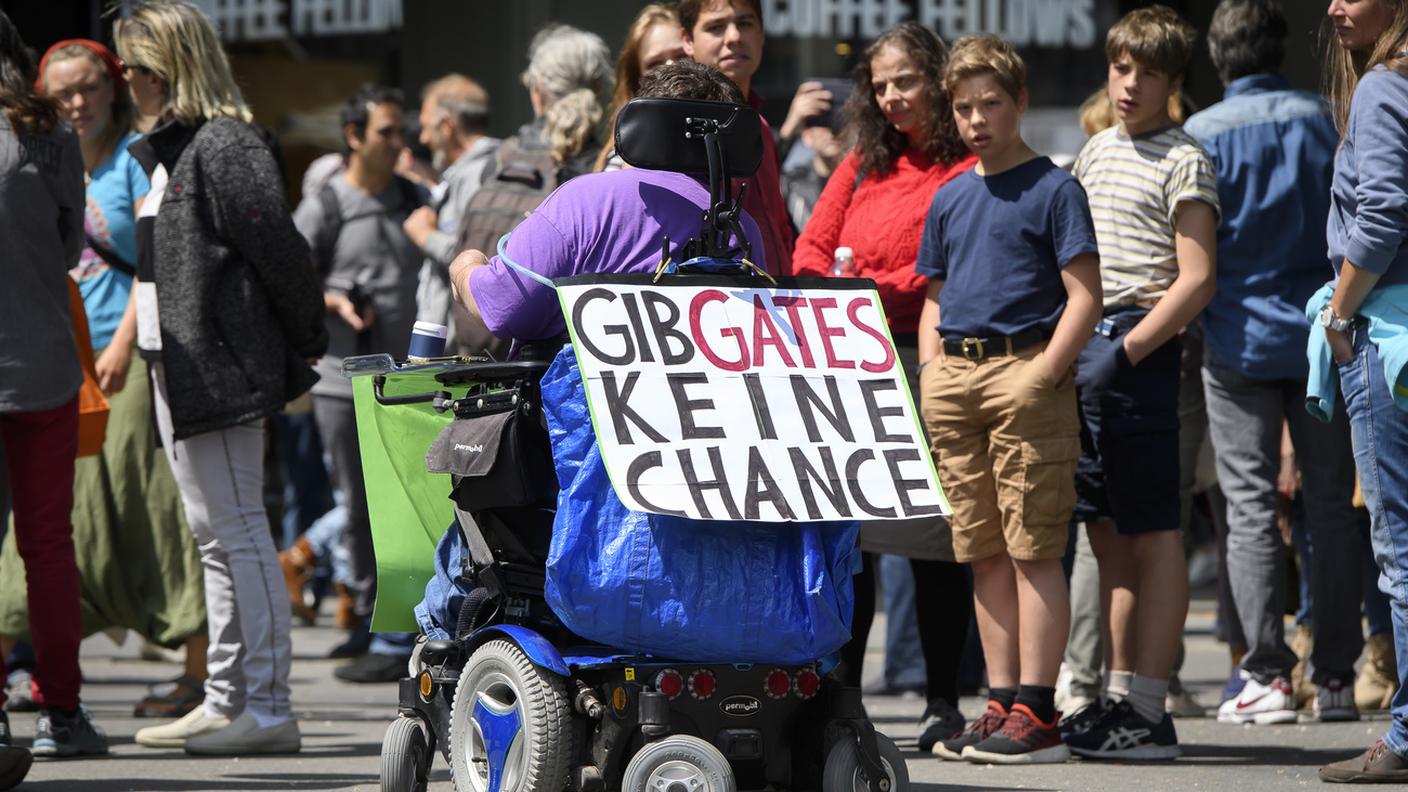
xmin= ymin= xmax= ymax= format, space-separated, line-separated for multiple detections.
xmin=1063 ymin=6 xmax=1219 ymax=760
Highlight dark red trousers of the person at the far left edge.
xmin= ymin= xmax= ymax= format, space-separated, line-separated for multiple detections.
xmin=0 ymin=399 xmax=83 ymax=710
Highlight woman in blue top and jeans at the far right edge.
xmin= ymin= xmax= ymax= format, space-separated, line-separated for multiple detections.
xmin=1307 ymin=0 xmax=1408 ymax=784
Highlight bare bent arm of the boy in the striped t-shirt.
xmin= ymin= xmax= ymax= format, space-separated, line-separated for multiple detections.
xmin=1124 ymin=200 xmax=1218 ymax=365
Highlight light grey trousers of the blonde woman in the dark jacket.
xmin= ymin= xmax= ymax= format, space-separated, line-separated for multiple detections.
xmin=151 ymin=364 xmax=293 ymax=723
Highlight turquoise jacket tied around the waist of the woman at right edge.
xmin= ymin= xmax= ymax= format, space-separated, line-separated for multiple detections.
xmin=1305 ymin=283 xmax=1408 ymax=421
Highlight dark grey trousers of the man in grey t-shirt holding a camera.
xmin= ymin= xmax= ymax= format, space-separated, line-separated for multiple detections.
xmin=313 ymin=395 xmax=376 ymax=620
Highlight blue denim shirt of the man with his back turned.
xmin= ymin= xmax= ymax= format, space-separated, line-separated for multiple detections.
xmin=1183 ymin=75 xmax=1339 ymax=379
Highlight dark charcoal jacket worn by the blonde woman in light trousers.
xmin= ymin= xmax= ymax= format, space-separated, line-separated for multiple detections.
xmin=131 ymin=118 xmax=328 ymax=440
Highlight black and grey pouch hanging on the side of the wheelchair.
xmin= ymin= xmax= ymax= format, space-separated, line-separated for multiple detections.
xmin=425 ymin=402 xmax=558 ymax=513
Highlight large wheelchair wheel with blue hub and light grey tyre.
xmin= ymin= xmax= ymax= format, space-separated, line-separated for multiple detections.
xmin=449 ymin=640 xmax=574 ymax=792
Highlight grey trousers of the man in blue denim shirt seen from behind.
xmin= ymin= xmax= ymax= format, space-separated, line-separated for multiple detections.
xmin=1202 ymin=359 xmax=1364 ymax=683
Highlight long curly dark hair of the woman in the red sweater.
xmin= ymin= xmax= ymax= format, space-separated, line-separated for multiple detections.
xmin=845 ymin=21 xmax=967 ymax=173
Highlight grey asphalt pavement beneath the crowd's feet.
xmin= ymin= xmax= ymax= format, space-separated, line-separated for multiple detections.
xmin=2 ymin=602 xmax=1387 ymax=792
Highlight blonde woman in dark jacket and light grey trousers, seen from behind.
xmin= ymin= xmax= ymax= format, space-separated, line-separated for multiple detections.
xmin=114 ymin=0 xmax=327 ymax=755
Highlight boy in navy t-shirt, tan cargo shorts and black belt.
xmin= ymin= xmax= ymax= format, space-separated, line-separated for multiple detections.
xmin=915 ymin=35 xmax=1101 ymax=764
